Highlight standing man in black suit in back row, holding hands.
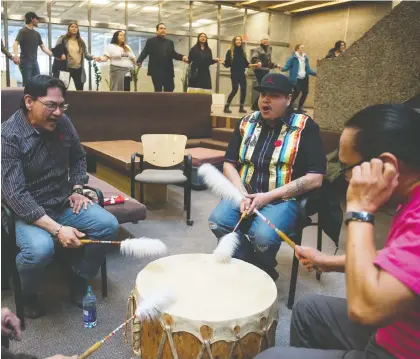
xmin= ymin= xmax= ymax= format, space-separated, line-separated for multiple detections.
xmin=137 ymin=23 xmax=188 ymax=92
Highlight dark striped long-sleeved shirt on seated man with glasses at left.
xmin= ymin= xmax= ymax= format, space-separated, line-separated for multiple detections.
xmin=1 ymin=110 xmax=88 ymax=223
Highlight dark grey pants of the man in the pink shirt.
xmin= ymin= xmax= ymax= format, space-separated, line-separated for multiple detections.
xmin=255 ymin=295 xmax=396 ymax=359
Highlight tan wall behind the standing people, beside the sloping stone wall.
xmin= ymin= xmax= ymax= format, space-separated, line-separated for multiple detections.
xmin=289 ymin=1 xmax=392 ymax=107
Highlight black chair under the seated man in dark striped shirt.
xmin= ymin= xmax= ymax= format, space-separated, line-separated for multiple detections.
xmin=1 ymin=186 xmax=108 ymax=329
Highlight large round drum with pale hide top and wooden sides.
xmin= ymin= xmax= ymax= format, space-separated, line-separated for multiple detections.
xmin=129 ymin=254 xmax=277 ymax=359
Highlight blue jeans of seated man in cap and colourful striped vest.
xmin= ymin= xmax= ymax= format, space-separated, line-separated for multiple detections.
xmin=209 ymin=200 xmax=298 ymax=272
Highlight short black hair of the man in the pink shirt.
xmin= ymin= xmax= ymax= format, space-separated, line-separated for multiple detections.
xmin=345 ymin=104 xmax=420 ymax=170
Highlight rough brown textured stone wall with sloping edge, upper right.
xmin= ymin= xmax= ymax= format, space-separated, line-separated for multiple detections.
xmin=314 ymin=1 xmax=420 ymax=131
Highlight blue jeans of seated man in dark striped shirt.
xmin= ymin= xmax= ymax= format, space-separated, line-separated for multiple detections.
xmin=16 ymin=203 xmax=119 ymax=295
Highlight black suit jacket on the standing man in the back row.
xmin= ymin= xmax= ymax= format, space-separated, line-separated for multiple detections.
xmin=137 ymin=36 xmax=183 ymax=77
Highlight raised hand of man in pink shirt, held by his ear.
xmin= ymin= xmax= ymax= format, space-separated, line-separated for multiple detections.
xmin=347 ymin=158 xmax=398 ymax=213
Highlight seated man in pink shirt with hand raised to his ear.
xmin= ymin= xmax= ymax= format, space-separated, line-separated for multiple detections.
xmin=256 ymin=105 xmax=420 ymax=359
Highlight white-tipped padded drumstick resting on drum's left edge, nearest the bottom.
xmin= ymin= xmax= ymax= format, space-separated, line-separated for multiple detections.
xmin=78 ymin=290 xmax=175 ymax=359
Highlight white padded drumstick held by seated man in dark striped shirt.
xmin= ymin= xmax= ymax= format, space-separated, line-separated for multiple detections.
xmin=80 ymin=237 xmax=167 ymax=258
